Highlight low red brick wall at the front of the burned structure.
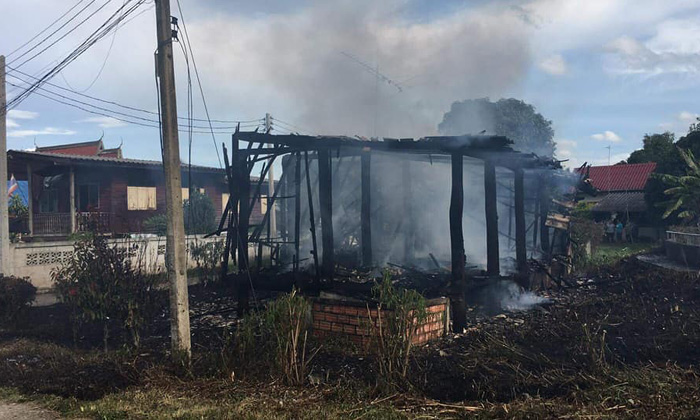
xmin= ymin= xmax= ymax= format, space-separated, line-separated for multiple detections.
xmin=311 ymin=298 xmax=449 ymax=346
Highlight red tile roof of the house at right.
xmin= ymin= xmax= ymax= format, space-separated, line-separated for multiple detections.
xmin=576 ymin=162 xmax=656 ymax=191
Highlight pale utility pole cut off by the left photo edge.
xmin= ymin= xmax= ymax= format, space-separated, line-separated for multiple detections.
xmin=0 ymin=55 xmax=12 ymax=276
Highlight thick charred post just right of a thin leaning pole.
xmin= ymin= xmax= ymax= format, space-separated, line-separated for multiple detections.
xmin=318 ymin=148 xmax=334 ymax=280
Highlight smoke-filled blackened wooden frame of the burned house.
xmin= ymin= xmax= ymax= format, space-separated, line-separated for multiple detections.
xmin=215 ymin=131 xmax=560 ymax=330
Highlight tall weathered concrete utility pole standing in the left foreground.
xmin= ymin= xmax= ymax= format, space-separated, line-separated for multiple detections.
xmin=156 ymin=0 xmax=191 ymax=359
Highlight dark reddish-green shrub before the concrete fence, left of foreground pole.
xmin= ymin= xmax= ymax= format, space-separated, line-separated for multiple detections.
xmin=51 ymin=235 xmax=158 ymax=350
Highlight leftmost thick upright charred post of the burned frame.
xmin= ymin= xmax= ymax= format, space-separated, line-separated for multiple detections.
xmin=234 ymin=136 xmax=250 ymax=314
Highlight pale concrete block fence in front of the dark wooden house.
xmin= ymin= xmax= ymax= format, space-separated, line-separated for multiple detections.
xmin=10 ymin=235 xmax=224 ymax=290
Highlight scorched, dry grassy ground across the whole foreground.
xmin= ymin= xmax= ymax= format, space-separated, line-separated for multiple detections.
xmin=0 ymin=254 xmax=700 ymax=419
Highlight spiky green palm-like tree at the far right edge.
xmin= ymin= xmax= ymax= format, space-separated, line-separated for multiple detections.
xmin=661 ymin=149 xmax=700 ymax=223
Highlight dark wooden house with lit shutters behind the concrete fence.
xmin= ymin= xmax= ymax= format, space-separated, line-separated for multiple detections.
xmin=7 ymin=140 xmax=266 ymax=238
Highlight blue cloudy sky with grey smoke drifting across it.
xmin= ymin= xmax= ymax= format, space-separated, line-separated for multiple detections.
xmin=0 ymin=0 xmax=700 ymax=171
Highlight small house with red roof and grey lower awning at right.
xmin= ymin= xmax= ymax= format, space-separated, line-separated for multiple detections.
xmin=576 ymin=162 xmax=656 ymax=220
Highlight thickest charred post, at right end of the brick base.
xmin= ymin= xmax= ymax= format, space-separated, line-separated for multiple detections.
xmin=450 ymin=153 xmax=467 ymax=333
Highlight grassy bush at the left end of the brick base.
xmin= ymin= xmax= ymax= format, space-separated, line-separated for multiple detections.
xmin=222 ymin=290 xmax=318 ymax=385
